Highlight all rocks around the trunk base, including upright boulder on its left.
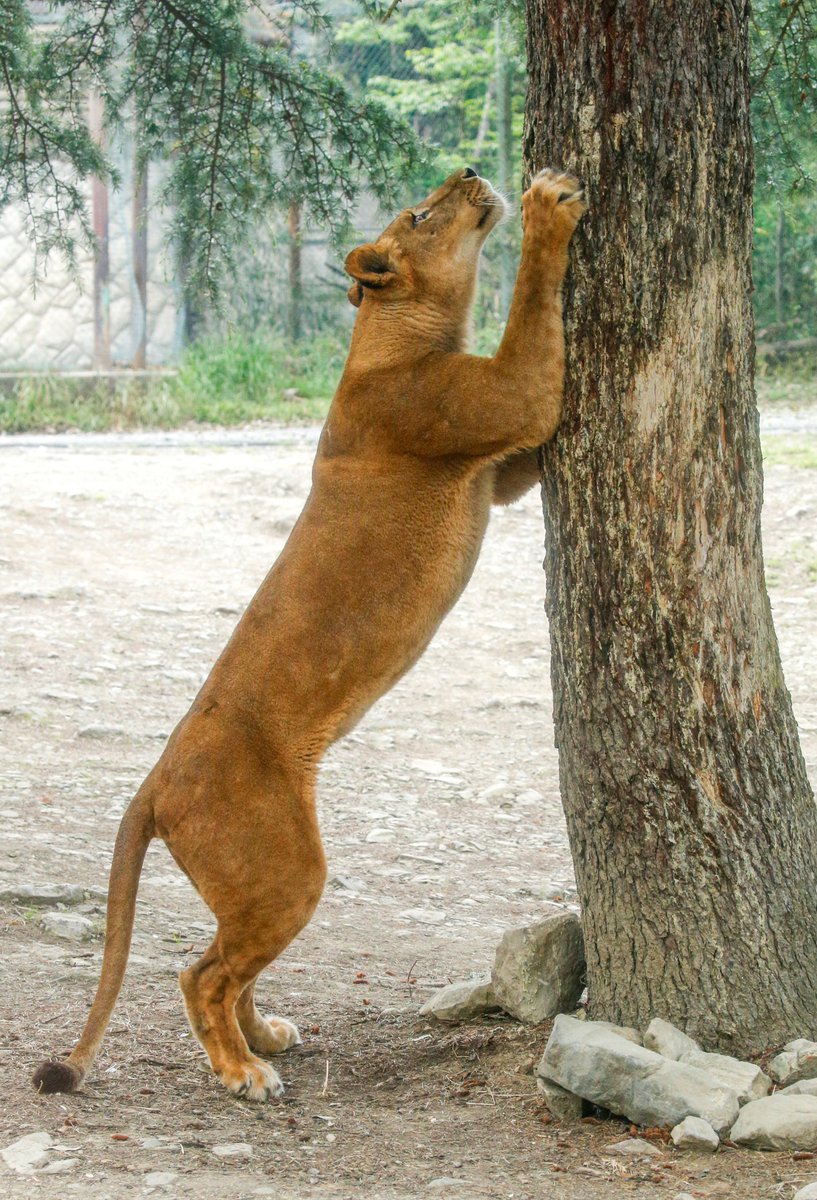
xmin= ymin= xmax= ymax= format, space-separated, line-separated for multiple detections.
xmin=420 ymin=905 xmax=817 ymax=1161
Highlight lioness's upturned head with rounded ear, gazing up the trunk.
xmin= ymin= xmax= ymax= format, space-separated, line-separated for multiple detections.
xmin=346 ymin=167 xmax=506 ymax=319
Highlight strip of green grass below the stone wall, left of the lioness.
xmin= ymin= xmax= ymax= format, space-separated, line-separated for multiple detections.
xmin=0 ymin=336 xmax=340 ymax=433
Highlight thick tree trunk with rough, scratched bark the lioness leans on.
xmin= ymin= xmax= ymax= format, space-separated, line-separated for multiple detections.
xmin=525 ymin=0 xmax=817 ymax=1052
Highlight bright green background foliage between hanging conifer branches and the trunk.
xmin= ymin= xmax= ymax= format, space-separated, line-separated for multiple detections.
xmin=335 ymin=0 xmax=525 ymax=331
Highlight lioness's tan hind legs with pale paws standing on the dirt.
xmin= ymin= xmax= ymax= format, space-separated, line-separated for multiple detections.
xmin=166 ymin=779 xmax=326 ymax=1100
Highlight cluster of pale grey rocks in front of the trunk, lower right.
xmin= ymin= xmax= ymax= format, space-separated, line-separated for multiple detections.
xmin=536 ymin=1014 xmax=817 ymax=1151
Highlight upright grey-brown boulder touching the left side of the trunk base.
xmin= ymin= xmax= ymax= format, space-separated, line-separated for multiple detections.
xmin=491 ymin=908 xmax=584 ymax=1025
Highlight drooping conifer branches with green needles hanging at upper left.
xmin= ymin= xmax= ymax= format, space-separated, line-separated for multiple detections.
xmin=0 ymin=0 xmax=419 ymax=296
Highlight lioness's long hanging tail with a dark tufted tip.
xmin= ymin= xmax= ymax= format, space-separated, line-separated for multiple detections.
xmin=32 ymin=787 xmax=155 ymax=1092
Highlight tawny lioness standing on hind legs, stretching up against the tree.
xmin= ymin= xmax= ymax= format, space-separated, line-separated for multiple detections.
xmin=34 ymin=169 xmax=583 ymax=1100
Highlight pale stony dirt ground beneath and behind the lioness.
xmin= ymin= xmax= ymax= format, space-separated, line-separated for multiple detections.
xmin=0 ymin=413 xmax=817 ymax=1200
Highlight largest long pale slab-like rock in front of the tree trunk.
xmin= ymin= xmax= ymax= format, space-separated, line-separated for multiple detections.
xmin=539 ymin=1015 xmax=739 ymax=1134
